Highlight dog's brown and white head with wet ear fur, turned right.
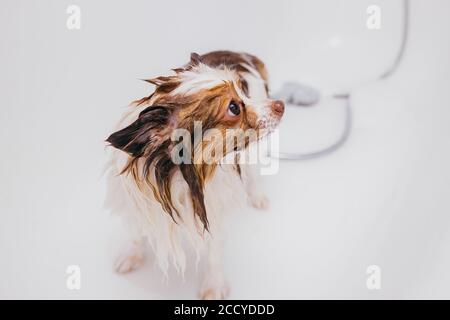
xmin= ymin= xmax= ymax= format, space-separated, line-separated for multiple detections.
xmin=107 ymin=54 xmax=284 ymax=229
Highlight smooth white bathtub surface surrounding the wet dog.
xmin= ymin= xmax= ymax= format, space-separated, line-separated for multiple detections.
xmin=0 ymin=0 xmax=450 ymax=299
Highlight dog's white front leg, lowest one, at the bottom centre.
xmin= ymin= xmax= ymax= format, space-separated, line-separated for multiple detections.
xmin=200 ymin=234 xmax=230 ymax=300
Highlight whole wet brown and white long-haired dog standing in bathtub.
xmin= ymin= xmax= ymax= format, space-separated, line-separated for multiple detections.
xmin=106 ymin=51 xmax=284 ymax=299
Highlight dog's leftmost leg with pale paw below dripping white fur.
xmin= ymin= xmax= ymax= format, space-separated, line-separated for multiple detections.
xmin=114 ymin=237 xmax=146 ymax=273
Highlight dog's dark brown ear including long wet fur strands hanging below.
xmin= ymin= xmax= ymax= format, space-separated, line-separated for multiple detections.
xmin=106 ymin=106 xmax=208 ymax=231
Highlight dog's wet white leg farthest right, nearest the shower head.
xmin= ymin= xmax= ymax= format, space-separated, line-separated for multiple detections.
xmin=241 ymin=165 xmax=269 ymax=209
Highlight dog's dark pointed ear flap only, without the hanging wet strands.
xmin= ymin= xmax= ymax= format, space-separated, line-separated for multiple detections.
xmin=106 ymin=106 xmax=173 ymax=158
